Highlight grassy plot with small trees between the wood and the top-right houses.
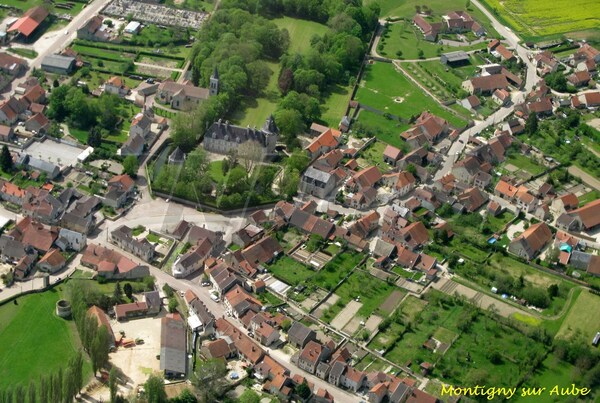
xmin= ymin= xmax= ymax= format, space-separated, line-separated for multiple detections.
xmin=377 ymin=22 xmax=486 ymax=60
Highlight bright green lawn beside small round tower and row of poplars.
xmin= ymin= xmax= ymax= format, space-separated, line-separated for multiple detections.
xmin=0 ymin=289 xmax=91 ymax=389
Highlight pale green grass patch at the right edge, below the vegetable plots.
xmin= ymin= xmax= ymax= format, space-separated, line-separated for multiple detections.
xmin=556 ymin=291 xmax=600 ymax=340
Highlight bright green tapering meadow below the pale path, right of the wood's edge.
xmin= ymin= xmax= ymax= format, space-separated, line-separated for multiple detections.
xmin=355 ymin=62 xmax=466 ymax=127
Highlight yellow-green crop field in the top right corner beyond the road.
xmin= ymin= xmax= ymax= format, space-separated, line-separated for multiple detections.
xmin=482 ymin=0 xmax=600 ymax=38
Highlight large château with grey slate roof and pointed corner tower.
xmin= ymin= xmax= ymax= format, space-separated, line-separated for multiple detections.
xmin=202 ymin=116 xmax=279 ymax=156
